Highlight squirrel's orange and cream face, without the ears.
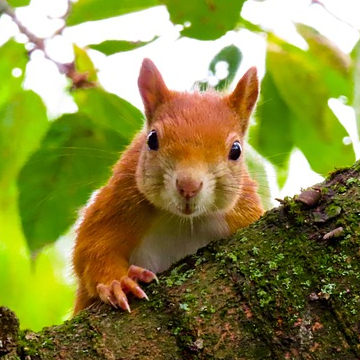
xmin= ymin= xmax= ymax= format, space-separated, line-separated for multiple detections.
xmin=137 ymin=94 xmax=248 ymax=217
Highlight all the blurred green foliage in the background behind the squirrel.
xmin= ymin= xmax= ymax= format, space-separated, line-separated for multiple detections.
xmin=0 ymin=0 xmax=360 ymax=329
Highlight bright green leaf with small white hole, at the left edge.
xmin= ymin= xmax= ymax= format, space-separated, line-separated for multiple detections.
xmin=0 ymin=41 xmax=28 ymax=106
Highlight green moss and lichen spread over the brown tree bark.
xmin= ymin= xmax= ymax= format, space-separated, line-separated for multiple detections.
xmin=14 ymin=165 xmax=360 ymax=359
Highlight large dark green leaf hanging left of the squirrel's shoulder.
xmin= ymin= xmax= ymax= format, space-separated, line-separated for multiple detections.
xmin=18 ymin=113 xmax=126 ymax=251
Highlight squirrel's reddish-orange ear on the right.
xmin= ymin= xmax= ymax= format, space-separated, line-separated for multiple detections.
xmin=228 ymin=67 xmax=259 ymax=132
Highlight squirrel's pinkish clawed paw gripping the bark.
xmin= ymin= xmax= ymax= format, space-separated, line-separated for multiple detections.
xmin=96 ymin=265 xmax=158 ymax=312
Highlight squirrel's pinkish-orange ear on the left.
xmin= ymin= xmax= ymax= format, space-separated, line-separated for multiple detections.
xmin=138 ymin=59 xmax=170 ymax=123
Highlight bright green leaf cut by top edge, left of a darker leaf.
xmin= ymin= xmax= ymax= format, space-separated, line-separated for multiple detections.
xmin=67 ymin=0 xmax=160 ymax=26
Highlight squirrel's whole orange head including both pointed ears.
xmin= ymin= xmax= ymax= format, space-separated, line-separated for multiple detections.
xmin=136 ymin=59 xmax=259 ymax=217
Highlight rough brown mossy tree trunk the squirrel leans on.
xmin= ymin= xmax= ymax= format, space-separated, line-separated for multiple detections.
xmin=0 ymin=163 xmax=360 ymax=360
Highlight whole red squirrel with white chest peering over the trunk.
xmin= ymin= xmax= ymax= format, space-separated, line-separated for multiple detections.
xmin=73 ymin=59 xmax=263 ymax=314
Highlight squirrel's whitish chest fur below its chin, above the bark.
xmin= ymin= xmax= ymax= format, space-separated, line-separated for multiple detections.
xmin=130 ymin=214 xmax=229 ymax=273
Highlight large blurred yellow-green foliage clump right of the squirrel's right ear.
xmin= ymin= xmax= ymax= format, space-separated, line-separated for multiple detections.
xmin=250 ymin=35 xmax=354 ymax=184
